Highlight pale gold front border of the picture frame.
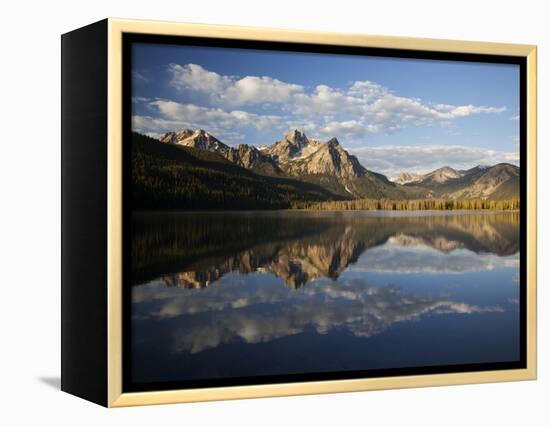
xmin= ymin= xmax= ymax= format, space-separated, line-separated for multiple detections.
xmin=61 ymin=18 xmax=537 ymax=407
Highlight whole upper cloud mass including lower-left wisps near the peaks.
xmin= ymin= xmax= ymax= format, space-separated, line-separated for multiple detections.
xmin=132 ymin=63 xmax=506 ymax=140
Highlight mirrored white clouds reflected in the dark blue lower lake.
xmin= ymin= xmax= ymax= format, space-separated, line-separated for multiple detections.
xmin=134 ymin=280 xmax=503 ymax=353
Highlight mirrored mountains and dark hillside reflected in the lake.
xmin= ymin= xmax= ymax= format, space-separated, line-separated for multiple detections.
xmin=132 ymin=212 xmax=519 ymax=288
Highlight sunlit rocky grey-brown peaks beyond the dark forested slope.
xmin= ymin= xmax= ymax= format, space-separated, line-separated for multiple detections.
xmin=160 ymin=129 xmax=519 ymax=199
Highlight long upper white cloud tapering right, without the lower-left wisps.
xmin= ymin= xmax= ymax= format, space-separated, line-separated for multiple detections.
xmin=169 ymin=64 xmax=506 ymax=133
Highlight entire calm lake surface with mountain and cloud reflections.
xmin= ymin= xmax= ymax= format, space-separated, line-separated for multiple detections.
xmin=131 ymin=211 xmax=520 ymax=383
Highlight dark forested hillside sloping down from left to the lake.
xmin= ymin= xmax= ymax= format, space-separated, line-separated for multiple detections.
xmin=131 ymin=133 xmax=345 ymax=210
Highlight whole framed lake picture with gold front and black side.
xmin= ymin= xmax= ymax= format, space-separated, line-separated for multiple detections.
xmin=62 ymin=19 xmax=536 ymax=407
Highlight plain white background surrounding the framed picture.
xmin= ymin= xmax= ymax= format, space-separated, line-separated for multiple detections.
xmin=0 ymin=0 xmax=550 ymax=426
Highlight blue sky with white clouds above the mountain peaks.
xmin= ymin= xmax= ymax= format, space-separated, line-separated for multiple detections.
xmin=132 ymin=44 xmax=519 ymax=176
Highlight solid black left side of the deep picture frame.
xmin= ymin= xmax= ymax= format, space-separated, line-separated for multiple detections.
xmin=61 ymin=19 xmax=108 ymax=406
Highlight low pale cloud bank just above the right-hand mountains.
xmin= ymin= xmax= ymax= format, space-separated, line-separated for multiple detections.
xmin=349 ymin=145 xmax=519 ymax=176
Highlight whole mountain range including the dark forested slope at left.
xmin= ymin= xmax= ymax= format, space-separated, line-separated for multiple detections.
xmin=132 ymin=129 xmax=519 ymax=208
